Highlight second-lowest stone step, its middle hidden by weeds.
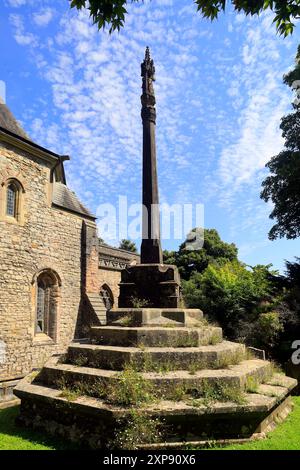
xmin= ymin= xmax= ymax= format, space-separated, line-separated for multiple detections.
xmin=36 ymin=358 xmax=272 ymax=398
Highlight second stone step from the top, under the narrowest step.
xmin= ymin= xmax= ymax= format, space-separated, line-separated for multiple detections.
xmin=90 ymin=326 xmax=222 ymax=347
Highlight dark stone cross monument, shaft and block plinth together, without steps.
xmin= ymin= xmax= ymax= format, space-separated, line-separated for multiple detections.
xmin=119 ymin=47 xmax=180 ymax=309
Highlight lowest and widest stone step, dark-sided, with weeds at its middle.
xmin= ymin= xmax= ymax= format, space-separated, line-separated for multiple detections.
xmin=15 ymin=377 xmax=297 ymax=449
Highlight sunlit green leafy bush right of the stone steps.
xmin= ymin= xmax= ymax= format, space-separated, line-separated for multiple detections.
xmin=182 ymin=260 xmax=283 ymax=349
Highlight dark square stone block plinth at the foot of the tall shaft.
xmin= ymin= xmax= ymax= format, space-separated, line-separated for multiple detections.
xmin=119 ymin=264 xmax=180 ymax=308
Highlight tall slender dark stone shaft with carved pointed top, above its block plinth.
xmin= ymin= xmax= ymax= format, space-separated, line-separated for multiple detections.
xmin=141 ymin=47 xmax=163 ymax=264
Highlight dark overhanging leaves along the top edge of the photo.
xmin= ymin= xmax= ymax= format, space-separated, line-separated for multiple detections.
xmin=69 ymin=0 xmax=300 ymax=36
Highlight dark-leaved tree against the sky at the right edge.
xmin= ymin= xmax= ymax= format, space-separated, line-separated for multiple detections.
xmin=261 ymin=46 xmax=300 ymax=240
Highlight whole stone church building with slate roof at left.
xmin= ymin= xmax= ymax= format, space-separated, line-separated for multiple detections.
xmin=0 ymin=101 xmax=139 ymax=404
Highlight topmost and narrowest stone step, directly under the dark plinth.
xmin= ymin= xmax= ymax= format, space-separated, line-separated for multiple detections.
xmin=107 ymin=308 xmax=203 ymax=327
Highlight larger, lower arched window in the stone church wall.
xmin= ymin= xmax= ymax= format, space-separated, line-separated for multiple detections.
xmin=35 ymin=270 xmax=59 ymax=340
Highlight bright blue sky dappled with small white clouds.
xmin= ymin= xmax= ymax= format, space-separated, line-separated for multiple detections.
xmin=0 ymin=0 xmax=300 ymax=269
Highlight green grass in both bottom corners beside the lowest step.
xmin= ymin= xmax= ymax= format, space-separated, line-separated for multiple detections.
xmin=0 ymin=397 xmax=300 ymax=450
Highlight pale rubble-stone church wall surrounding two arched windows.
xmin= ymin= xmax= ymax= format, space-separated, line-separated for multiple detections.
xmin=0 ymin=143 xmax=93 ymax=381
